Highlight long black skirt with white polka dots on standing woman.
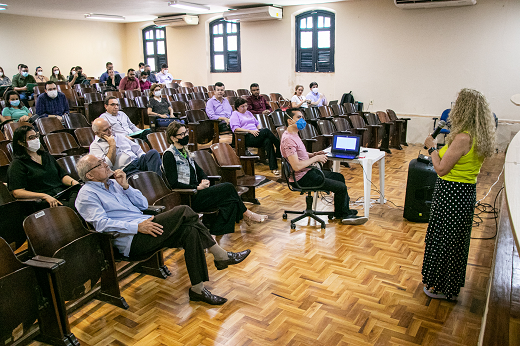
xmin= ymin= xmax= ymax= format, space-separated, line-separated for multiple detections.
xmin=422 ymin=177 xmax=477 ymax=299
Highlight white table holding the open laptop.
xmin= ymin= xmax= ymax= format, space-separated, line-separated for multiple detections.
xmin=324 ymin=147 xmax=385 ymax=217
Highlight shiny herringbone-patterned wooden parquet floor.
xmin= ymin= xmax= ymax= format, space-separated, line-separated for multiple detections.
xmin=33 ymin=146 xmax=504 ymax=346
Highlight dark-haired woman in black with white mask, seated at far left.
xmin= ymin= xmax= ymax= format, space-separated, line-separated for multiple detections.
xmin=7 ymin=126 xmax=79 ymax=208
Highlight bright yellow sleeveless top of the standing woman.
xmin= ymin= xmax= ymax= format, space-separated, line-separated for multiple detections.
xmin=439 ymin=135 xmax=484 ymax=184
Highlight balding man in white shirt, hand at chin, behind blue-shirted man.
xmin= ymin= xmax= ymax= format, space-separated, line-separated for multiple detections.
xmin=90 ymin=118 xmax=162 ymax=176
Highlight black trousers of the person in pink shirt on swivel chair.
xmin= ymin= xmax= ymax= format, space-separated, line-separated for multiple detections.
xmin=298 ymin=169 xmax=350 ymax=218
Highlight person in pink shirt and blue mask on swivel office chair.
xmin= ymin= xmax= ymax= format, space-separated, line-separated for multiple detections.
xmin=280 ymin=108 xmax=368 ymax=225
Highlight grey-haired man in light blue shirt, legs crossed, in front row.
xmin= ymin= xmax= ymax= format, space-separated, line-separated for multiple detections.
xmin=75 ymin=155 xmax=251 ymax=305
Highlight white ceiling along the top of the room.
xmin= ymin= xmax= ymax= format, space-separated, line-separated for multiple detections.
xmin=0 ymin=0 xmax=342 ymax=23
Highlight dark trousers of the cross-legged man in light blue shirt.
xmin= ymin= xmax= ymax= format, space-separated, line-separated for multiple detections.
xmin=130 ymin=205 xmax=216 ymax=285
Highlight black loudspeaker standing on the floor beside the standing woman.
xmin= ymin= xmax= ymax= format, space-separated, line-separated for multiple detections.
xmin=403 ymin=155 xmax=437 ymax=222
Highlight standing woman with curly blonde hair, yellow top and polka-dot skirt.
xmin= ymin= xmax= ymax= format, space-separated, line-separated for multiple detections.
xmin=422 ymin=89 xmax=495 ymax=299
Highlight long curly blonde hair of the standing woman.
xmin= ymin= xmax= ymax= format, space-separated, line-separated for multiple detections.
xmin=446 ymin=89 xmax=495 ymax=158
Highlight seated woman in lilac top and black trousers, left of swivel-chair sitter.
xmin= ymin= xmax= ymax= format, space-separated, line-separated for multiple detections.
xmin=229 ymin=98 xmax=280 ymax=175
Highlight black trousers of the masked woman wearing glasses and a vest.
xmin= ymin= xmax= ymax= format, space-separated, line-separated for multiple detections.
xmin=191 ymin=183 xmax=247 ymax=235
